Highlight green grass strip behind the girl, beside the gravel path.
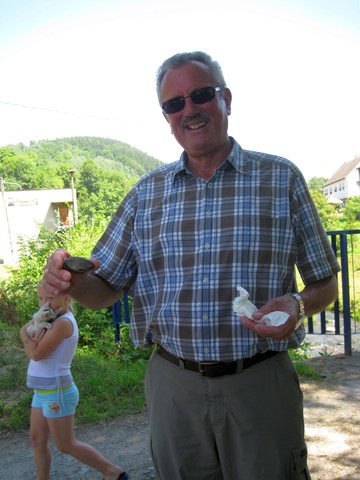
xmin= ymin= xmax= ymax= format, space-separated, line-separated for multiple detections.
xmin=0 ymin=347 xmax=147 ymax=430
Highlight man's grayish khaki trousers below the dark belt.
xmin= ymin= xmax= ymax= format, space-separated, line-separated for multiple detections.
xmin=145 ymin=352 xmax=310 ymax=480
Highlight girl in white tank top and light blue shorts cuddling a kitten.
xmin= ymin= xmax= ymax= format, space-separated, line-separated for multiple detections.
xmin=20 ymin=281 xmax=128 ymax=480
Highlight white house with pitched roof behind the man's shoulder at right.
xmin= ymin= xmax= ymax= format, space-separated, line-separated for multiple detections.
xmin=322 ymin=155 xmax=360 ymax=204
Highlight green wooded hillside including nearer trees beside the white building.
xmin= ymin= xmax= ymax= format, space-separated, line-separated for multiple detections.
xmin=0 ymin=137 xmax=163 ymax=221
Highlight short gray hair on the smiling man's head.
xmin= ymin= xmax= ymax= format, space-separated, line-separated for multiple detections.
xmin=156 ymin=51 xmax=226 ymax=102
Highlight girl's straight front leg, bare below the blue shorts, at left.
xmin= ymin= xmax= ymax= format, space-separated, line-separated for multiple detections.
xmin=30 ymin=407 xmax=51 ymax=480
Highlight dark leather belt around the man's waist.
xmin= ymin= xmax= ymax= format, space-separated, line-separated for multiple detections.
xmin=155 ymin=343 xmax=280 ymax=378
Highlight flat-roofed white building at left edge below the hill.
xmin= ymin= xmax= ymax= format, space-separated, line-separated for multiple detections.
xmin=0 ymin=185 xmax=77 ymax=265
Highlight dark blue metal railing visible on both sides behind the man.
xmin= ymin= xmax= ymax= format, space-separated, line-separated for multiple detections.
xmin=112 ymin=230 xmax=360 ymax=355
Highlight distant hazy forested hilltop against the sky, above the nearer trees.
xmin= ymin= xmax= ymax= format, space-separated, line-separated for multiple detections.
xmin=0 ymin=137 xmax=162 ymax=188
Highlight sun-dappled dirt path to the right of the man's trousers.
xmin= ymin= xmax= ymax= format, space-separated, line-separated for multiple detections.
xmin=302 ymin=352 xmax=360 ymax=480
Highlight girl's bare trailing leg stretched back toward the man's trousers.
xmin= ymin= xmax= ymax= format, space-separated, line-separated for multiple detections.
xmin=47 ymin=415 xmax=123 ymax=480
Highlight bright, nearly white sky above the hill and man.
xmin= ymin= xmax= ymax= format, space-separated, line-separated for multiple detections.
xmin=0 ymin=0 xmax=360 ymax=180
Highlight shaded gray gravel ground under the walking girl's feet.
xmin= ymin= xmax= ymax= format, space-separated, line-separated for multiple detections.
xmin=0 ymin=411 xmax=155 ymax=480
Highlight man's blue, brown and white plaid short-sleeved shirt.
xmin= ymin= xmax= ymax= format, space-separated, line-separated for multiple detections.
xmin=93 ymin=139 xmax=339 ymax=361
